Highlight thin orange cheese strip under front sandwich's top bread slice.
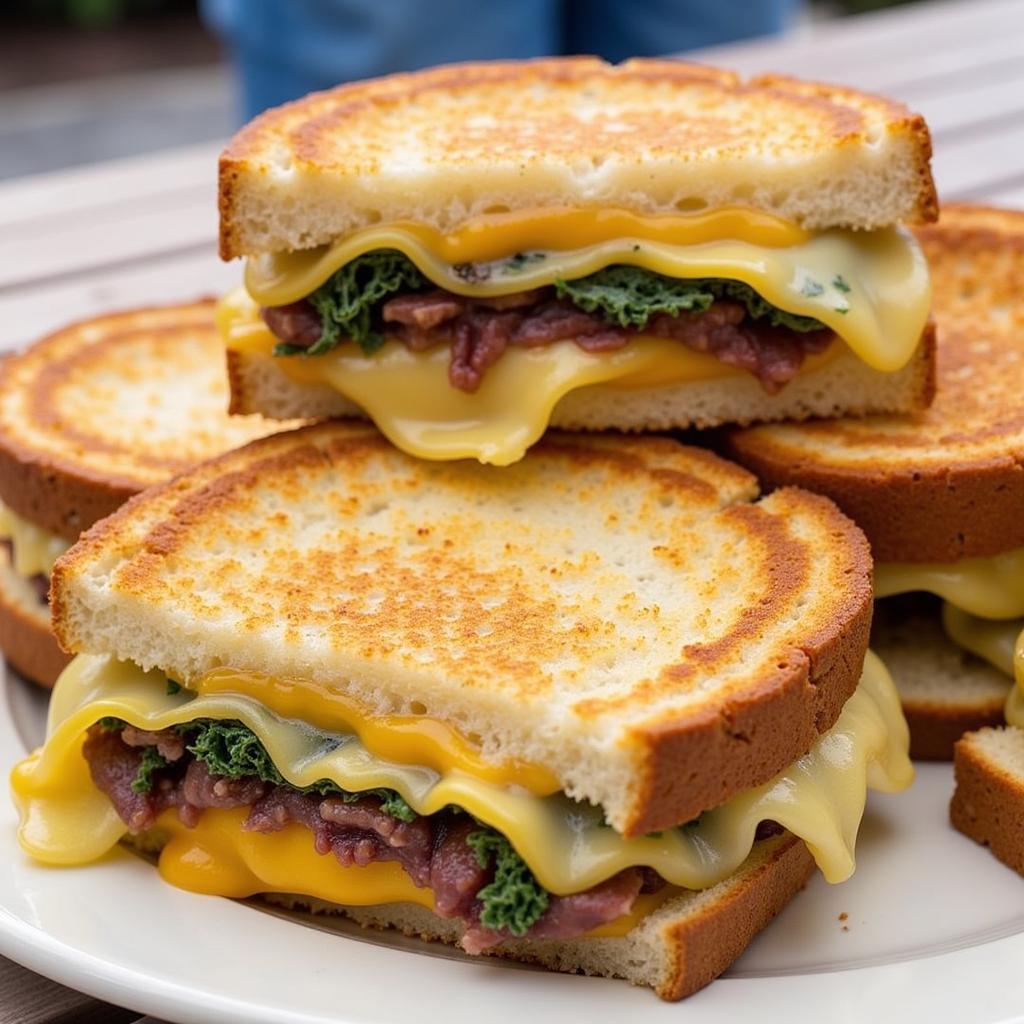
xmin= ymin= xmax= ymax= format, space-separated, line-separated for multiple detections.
xmin=191 ymin=669 xmax=561 ymax=797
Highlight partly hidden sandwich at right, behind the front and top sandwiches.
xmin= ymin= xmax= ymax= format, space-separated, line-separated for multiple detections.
xmin=726 ymin=206 xmax=1024 ymax=760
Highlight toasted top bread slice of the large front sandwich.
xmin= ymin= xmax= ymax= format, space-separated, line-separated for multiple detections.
xmin=52 ymin=422 xmax=872 ymax=835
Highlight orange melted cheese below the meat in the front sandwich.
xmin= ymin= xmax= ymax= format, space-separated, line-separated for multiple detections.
xmin=149 ymin=808 xmax=679 ymax=938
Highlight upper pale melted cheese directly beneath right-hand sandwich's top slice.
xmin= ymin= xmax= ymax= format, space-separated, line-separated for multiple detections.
xmin=874 ymin=548 xmax=1024 ymax=618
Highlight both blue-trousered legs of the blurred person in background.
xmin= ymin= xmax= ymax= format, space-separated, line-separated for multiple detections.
xmin=201 ymin=0 xmax=802 ymax=120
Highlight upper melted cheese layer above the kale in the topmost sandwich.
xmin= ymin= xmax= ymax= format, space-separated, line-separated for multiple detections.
xmin=245 ymin=209 xmax=931 ymax=373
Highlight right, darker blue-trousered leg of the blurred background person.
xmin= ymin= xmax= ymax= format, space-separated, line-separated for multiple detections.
xmin=562 ymin=0 xmax=803 ymax=61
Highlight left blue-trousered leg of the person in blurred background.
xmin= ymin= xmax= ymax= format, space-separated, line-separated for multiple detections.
xmin=201 ymin=0 xmax=562 ymax=120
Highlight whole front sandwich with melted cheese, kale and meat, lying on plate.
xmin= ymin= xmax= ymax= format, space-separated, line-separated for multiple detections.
xmin=12 ymin=422 xmax=911 ymax=998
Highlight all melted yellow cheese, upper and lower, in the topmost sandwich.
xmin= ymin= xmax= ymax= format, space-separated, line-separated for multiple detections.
xmin=218 ymin=208 xmax=931 ymax=465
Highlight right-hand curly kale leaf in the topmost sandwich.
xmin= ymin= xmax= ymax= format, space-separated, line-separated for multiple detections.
xmin=555 ymin=264 xmax=823 ymax=331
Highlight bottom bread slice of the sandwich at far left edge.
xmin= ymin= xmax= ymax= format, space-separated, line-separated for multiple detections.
xmin=0 ymin=546 xmax=71 ymax=687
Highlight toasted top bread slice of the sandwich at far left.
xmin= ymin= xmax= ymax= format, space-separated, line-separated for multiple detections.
xmin=0 ymin=298 xmax=296 ymax=541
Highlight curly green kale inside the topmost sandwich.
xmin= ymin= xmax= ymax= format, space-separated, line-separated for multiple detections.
xmin=273 ymin=249 xmax=831 ymax=355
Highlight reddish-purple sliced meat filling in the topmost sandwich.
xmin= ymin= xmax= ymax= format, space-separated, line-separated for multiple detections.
xmin=262 ymin=288 xmax=836 ymax=394
